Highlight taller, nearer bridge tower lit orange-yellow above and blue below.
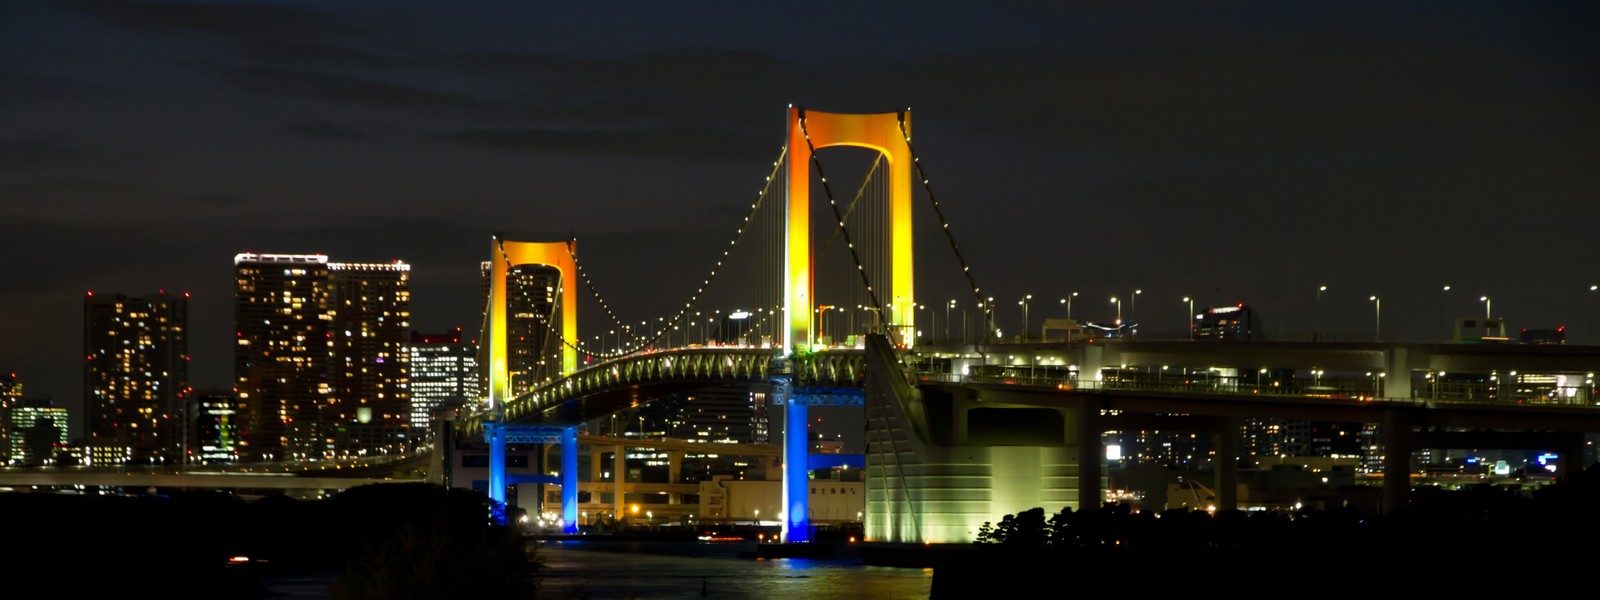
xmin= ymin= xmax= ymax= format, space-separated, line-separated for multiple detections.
xmin=771 ymin=106 xmax=917 ymax=542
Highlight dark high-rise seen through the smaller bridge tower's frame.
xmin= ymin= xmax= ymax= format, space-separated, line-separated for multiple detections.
xmin=478 ymin=261 xmax=562 ymax=394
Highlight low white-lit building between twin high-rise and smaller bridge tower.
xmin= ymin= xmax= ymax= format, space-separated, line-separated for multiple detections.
xmin=411 ymin=326 xmax=482 ymax=432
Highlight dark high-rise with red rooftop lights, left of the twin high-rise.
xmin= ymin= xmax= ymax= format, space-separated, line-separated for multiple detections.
xmin=83 ymin=291 xmax=189 ymax=462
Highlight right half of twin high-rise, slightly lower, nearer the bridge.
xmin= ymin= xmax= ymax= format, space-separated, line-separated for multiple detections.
xmin=322 ymin=261 xmax=411 ymax=456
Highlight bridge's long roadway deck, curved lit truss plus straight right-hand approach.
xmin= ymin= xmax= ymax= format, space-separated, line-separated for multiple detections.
xmin=459 ymin=339 xmax=1600 ymax=435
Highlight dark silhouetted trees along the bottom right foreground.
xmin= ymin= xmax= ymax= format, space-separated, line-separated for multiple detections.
xmin=934 ymin=464 xmax=1600 ymax=598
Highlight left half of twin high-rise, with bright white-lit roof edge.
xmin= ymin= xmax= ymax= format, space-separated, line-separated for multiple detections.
xmin=234 ymin=253 xmax=334 ymax=462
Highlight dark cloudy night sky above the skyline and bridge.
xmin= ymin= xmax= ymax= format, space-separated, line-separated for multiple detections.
xmin=0 ymin=0 xmax=1600 ymax=435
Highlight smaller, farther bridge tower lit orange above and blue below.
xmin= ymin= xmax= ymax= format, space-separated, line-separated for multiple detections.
xmin=483 ymin=235 xmax=579 ymax=533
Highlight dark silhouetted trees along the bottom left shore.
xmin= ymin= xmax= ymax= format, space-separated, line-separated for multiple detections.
xmin=0 ymin=483 xmax=539 ymax=598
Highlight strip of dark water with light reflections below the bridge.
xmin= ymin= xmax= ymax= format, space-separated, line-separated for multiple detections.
xmin=539 ymin=541 xmax=933 ymax=600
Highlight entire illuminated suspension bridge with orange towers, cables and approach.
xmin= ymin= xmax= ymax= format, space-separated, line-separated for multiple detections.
xmin=456 ymin=107 xmax=1600 ymax=544
